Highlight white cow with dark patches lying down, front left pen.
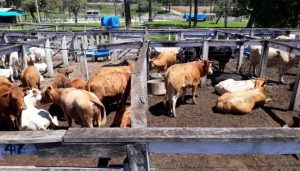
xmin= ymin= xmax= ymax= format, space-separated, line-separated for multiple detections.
xmin=20 ymin=89 xmax=58 ymax=131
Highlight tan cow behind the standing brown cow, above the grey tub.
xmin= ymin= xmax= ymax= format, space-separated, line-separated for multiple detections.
xmin=149 ymin=51 xmax=177 ymax=71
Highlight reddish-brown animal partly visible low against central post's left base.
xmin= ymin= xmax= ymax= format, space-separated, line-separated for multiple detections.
xmin=110 ymin=107 xmax=131 ymax=128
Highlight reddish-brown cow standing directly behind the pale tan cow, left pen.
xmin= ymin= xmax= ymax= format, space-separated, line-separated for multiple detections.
xmin=86 ymin=72 xmax=131 ymax=107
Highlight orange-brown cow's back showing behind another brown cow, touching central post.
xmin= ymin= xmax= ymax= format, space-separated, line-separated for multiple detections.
xmin=96 ymin=62 xmax=136 ymax=75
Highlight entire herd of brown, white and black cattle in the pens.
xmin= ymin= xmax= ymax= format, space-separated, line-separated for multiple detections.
xmin=0 ymin=35 xmax=298 ymax=130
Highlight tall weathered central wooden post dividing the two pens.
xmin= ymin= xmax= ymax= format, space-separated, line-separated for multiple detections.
xmin=130 ymin=42 xmax=148 ymax=128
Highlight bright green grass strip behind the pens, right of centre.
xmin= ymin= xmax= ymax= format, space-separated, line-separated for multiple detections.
xmin=146 ymin=21 xmax=247 ymax=28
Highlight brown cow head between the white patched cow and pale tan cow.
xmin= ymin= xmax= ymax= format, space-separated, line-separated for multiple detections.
xmin=41 ymin=86 xmax=60 ymax=104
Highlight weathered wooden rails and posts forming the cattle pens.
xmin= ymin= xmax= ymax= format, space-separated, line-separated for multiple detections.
xmin=0 ymin=26 xmax=300 ymax=170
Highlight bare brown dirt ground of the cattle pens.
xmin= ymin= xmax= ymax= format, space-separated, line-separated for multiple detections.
xmin=0 ymin=52 xmax=300 ymax=171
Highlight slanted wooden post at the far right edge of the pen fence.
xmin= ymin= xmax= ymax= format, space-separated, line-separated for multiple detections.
xmin=290 ymin=63 xmax=300 ymax=110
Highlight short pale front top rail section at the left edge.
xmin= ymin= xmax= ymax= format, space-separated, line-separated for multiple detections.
xmin=0 ymin=130 xmax=66 ymax=144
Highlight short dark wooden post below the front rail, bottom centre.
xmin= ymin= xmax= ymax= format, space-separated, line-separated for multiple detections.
xmin=127 ymin=144 xmax=150 ymax=171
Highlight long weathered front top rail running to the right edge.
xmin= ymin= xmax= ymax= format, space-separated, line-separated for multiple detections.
xmin=63 ymin=127 xmax=300 ymax=144
